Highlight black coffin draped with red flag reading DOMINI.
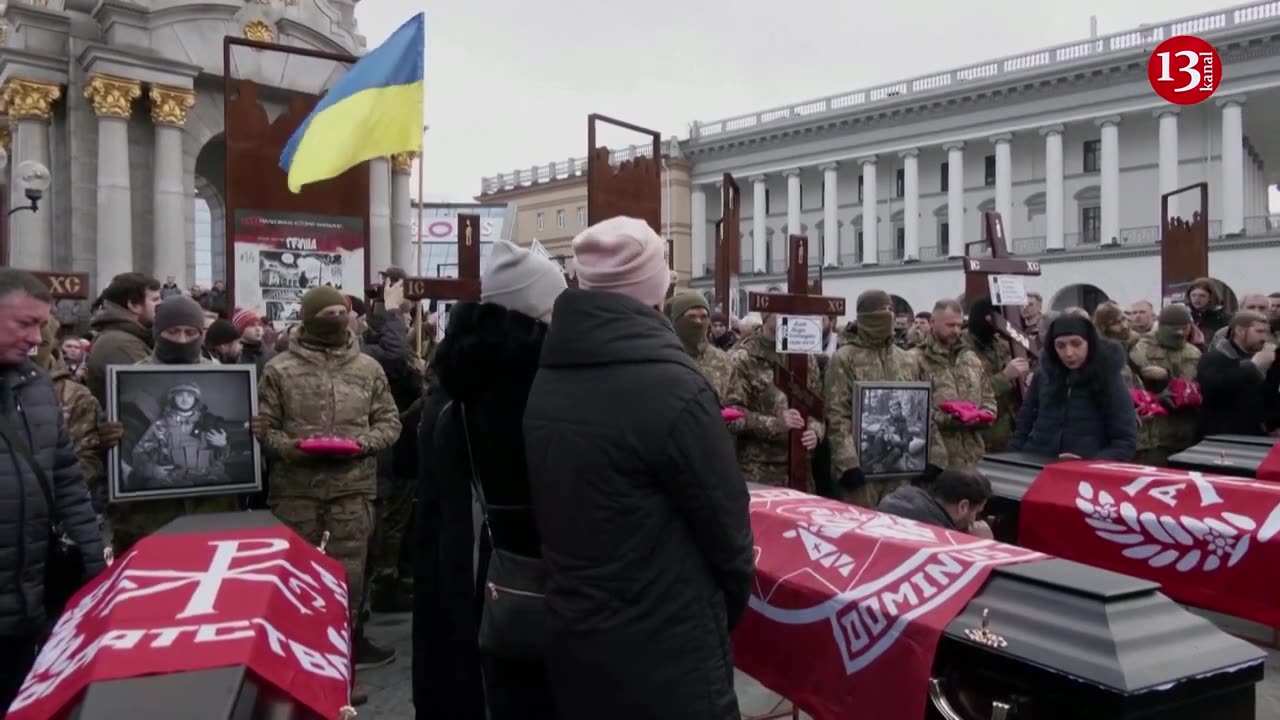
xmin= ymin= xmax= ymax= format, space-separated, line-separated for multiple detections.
xmin=733 ymin=481 xmax=1265 ymax=720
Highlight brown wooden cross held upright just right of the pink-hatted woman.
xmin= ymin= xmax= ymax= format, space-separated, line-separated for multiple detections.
xmin=746 ymin=234 xmax=845 ymax=491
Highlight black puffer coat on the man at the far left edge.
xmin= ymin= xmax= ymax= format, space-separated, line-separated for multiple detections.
xmin=0 ymin=361 xmax=106 ymax=637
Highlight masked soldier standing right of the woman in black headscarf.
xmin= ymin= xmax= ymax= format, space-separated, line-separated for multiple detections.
xmin=1129 ymin=305 xmax=1201 ymax=465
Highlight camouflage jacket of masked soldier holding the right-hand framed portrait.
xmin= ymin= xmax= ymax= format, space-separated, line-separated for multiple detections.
xmin=823 ymin=324 xmax=942 ymax=479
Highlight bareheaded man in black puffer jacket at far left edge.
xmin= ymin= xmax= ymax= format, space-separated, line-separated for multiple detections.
xmin=0 ymin=268 xmax=106 ymax=714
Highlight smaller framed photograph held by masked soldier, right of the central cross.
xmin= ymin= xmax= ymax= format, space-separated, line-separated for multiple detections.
xmin=854 ymin=382 xmax=932 ymax=480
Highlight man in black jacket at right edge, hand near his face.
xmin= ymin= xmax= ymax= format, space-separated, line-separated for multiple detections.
xmin=1196 ymin=310 xmax=1280 ymax=436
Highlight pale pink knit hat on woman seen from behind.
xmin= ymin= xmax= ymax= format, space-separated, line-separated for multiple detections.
xmin=573 ymin=215 xmax=671 ymax=307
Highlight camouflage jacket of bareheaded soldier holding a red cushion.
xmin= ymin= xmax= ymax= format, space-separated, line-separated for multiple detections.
xmin=911 ymin=336 xmax=998 ymax=469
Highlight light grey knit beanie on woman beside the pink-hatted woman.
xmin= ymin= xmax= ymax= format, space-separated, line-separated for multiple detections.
xmin=480 ymin=240 xmax=567 ymax=320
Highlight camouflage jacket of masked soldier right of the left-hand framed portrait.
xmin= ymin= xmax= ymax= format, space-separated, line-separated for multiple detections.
xmin=257 ymin=337 xmax=401 ymax=500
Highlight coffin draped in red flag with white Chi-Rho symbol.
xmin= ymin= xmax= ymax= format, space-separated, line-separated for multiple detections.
xmin=6 ymin=511 xmax=351 ymax=720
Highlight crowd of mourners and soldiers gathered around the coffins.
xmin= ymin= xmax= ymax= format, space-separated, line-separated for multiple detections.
xmin=0 ymin=218 xmax=1280 ymax=720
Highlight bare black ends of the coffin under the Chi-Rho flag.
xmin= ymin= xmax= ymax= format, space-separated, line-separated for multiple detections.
xmin=68 ymin=511 xmax=335 ymax=720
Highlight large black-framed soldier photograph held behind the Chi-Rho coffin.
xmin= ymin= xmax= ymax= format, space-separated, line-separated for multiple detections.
xmin=106 ymin=365 xmax=262 ymax=502
